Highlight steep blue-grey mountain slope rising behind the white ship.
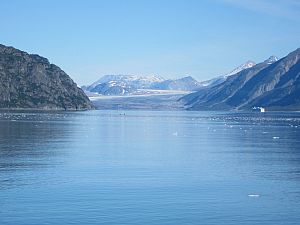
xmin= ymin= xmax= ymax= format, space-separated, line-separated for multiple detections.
xmin=180 ymin=49 xmax=300 ymax=110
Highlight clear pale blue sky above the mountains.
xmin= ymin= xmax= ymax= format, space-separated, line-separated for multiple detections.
xmin=0 ymin=0 xmax=300 ymax=85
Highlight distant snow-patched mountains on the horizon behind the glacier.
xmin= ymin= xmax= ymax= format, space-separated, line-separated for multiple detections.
xmin=82 ymin=61 xmax=262 ymax=96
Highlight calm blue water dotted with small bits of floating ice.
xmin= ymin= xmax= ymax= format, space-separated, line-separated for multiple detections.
xmin=0 ymin=111 xmax=300 ymax=225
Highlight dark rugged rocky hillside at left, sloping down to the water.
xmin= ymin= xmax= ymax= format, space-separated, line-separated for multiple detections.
xmin=0 ymin=45 xmax=92 ymax=110
